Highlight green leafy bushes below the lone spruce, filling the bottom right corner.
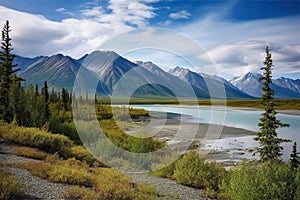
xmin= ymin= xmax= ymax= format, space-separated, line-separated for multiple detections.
xmin=152 ymin=152 xmax=300 ymax=200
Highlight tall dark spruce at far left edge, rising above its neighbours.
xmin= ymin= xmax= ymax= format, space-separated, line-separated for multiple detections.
xmin=0 ymin=21 xmax=20 ymax=121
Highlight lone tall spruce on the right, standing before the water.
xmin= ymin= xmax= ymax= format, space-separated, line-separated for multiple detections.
xmin=254 ymin=46 xmax=289 ymax=161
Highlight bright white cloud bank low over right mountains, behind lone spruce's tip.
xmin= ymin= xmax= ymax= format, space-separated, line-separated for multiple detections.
xmin=199 ymin=41 xmax=300 ymax=77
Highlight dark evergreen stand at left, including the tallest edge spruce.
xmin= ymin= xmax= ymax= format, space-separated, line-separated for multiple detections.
xmin=0 ymin=21 xmax=72 ymax=128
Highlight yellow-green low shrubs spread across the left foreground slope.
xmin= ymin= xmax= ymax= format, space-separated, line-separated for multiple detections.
xmin=0 ymin=122 xmax=158 ymax=200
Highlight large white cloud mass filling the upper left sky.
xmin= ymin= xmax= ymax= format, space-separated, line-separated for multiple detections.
xmin=0 ymin=0 xmax=155 ymax=57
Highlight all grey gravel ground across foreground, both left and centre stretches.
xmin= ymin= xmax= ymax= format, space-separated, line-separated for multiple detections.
xmin=0 ymin=139 xmax=214 ymax=200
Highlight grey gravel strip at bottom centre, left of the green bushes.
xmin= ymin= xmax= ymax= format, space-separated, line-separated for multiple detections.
xmin=127 ymin=173 xmax=210 ymax=200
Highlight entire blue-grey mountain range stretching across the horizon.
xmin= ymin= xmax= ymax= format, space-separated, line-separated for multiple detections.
xmin=14 ymin=51 xmax=300 ymax=99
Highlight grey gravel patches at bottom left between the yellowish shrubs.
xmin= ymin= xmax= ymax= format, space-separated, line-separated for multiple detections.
xmin=0 ymin=141 xmax=68 ymax=200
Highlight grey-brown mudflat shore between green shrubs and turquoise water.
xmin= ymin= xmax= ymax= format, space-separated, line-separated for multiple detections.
xmin=126 ymin=119 xmax=255 ymax=166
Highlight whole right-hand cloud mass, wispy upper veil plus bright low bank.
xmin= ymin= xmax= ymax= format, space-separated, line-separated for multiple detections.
xmin=178 ymin=16 xmax=300 ymax=78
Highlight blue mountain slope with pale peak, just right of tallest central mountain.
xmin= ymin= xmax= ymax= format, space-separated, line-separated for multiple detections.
xmin=169 ymin=67 xmax=253 ymax=99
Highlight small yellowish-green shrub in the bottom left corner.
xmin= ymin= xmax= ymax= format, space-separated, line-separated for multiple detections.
xmin=0 ymin=169 xmax=25 ymax=200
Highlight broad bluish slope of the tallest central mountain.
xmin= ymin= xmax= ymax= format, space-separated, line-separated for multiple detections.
xmin=79 ymin=51 xmax=202 ymax=97
